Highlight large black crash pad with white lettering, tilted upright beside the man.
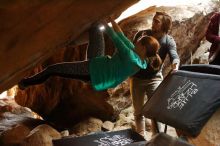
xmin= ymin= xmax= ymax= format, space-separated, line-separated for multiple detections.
xmin=143 ymin=65 xmax=220 ymax=136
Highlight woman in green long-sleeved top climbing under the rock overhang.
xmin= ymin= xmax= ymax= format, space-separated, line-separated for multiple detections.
xmin=18 ymin=18 xmax=161 ymax=91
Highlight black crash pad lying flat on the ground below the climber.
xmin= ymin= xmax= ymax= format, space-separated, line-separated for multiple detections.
xmin=53 ymin=129 xmax=145 ymax=146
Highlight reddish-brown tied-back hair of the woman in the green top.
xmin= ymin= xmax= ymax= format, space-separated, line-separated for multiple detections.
xmin=138 ymin=35 xmax=162 ymax=71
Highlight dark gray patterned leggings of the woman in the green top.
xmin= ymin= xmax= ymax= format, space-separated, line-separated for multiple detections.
xmin=19 ymin=26 xmax=105 ymax=87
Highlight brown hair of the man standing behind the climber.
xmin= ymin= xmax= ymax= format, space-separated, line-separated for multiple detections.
xmin=154 ymin=12 xmax=172 ymax=33
